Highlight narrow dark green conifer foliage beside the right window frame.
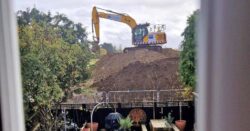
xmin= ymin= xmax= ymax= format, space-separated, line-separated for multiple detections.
xmin=179 ymin=10 xmax=199 ymax=89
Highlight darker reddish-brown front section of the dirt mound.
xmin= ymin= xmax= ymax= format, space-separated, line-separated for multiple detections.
xmin=93 ymin=58 xmax=180 ymax=91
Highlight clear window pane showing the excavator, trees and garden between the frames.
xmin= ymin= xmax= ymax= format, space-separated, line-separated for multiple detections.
xmin=15 ymin=0 xmax=199 ymax=131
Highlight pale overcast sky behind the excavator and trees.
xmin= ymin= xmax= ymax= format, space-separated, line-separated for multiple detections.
xmin=14 ymin=0 xmax=199 ymax=49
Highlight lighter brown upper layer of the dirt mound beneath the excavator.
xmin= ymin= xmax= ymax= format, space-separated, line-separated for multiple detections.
xmin=93 ymin=48 xmax=179 ymax=83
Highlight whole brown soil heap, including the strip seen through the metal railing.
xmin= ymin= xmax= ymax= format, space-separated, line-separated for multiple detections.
xmin=65 ymin=48 xmax=185 ymax=103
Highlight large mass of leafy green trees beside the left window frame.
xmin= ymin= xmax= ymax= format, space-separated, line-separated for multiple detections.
xmin=17 ymin=8 xmax=92 ymax=131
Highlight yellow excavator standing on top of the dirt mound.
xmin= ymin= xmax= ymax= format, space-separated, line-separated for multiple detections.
xmin=92 ymin=6 xmax=167 ymax=53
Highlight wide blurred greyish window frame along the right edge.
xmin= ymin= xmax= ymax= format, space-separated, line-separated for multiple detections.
xmin=196 ymin=0 xmax=250 ymax=131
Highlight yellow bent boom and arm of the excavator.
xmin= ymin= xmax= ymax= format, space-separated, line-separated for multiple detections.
xmin=92 ymin=7 xmax=137 ymax=44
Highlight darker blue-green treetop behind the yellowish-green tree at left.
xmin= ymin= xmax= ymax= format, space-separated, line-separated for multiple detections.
xmin=17 ymin=8 xmax=88 ymax=46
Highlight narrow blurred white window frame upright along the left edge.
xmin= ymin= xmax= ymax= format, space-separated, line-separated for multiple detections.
xmin=0 ymin=0 xmax=25 ymax=131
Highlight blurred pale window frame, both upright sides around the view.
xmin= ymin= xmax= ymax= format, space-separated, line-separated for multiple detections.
xmin=0 ymin=0 xmax=250 ymax=131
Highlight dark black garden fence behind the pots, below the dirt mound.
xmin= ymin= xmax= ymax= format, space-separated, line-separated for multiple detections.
xmin=61 ymin=102 xmax=195 ymax=131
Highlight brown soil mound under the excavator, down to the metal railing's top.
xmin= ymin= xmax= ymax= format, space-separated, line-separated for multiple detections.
xmin=92 ymin=48 xmax=180 ymax=91
